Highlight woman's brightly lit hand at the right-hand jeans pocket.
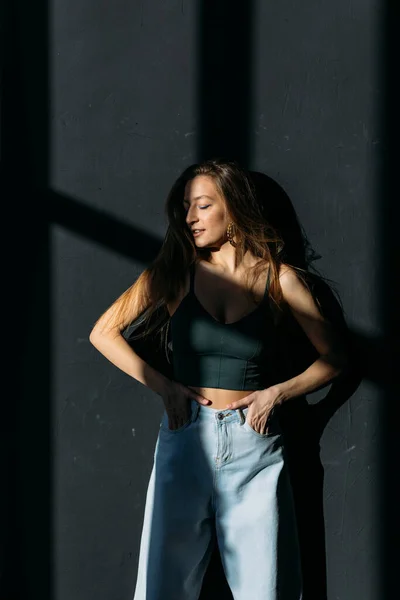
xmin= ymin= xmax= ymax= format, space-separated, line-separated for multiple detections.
xmin=226 ymin=386 xmax=281 ymax=434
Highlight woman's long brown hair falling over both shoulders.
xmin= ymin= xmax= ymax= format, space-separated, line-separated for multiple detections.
xmin=96 ymin=158 xmax=312 ymax=352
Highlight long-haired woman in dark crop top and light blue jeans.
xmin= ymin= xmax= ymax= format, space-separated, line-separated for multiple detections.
xmin=90 ymin=159 xmax=346 ymax=600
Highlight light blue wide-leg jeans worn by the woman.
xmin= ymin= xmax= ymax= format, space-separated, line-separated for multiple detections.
xmin=133 ymin=400 xmax=302 ymax=600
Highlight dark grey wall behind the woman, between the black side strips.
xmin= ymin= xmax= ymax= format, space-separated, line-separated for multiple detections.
xmin=3 ymin=0 xmax=388 ymax=600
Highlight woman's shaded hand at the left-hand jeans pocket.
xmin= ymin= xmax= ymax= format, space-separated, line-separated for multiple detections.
xmin=162 ymin=381 xmax=211 ymax=429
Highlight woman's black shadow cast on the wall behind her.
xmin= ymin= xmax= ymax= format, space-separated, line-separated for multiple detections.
xmin=126 ymin=171 xmax=362 ymax=600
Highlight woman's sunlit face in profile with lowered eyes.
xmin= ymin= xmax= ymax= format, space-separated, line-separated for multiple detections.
xmin=183 ymin=175 xmax=229 ymax=248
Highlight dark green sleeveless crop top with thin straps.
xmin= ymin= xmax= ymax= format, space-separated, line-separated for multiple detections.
xmin=170 ymin=265 xmax=277 ymax=390
